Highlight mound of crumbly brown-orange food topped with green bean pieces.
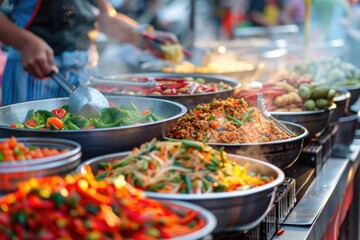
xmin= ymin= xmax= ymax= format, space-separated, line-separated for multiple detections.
xmin=167 ymin=98 xmax=293 ymax=143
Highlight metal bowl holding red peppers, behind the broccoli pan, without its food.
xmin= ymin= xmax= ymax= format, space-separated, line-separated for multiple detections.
xmin=90 ymin=73 xmax=241 ymax=109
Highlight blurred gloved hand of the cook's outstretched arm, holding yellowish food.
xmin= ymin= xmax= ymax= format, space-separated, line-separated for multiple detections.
xmin=137 ymin=31 xmax=183 ymax=64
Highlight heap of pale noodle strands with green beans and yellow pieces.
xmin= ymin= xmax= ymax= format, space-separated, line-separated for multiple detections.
xmin=92 ymin=139 xmax=274 ymax=194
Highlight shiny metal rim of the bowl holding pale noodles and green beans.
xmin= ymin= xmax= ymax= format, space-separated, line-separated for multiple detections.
xmin=76 ymin=151 xmax=285 ymax=201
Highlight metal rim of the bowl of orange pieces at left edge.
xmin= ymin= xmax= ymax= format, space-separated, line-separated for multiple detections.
xmin=0 ymin=137 xmax=81 ymax=167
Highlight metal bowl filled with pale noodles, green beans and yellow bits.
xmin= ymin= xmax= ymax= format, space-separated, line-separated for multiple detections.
xmin=77 ymin=139 xmax=284 ymax=232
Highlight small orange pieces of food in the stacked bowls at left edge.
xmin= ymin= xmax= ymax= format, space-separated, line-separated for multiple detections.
xmin=0 ymin=137 xmax=69 ymax=163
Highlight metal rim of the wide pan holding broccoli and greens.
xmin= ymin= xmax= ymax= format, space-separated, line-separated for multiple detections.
xmin=0 ymin=96 xmax=187 ymax=133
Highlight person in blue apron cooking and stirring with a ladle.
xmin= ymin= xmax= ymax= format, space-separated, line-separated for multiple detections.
xmin=0 ymin=0 xmax=178 ymax=105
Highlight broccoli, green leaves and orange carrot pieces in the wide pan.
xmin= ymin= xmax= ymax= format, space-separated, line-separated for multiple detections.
xmin=10 ymin=102 xmax=164 ymax=130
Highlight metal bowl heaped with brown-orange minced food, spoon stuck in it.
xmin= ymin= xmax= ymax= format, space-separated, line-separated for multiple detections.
xmin=166 ymin=98 xmax=308 ymax=168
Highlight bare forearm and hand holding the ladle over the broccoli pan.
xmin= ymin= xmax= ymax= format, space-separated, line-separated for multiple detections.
xmin=0 ymin=13 xmax=56 ymax=78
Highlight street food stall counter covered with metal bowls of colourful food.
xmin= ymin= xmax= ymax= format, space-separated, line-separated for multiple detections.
xmin=0 ymin=1 xmax=360 ymax=240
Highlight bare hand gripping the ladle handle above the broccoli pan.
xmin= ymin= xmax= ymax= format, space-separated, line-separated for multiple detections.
xmin=19 ymin=33 xmax=58 ymax=79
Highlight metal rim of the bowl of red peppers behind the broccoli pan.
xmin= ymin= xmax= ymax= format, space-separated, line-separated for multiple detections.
xmin=90 ymin=72 xmax=241 ymax=96
